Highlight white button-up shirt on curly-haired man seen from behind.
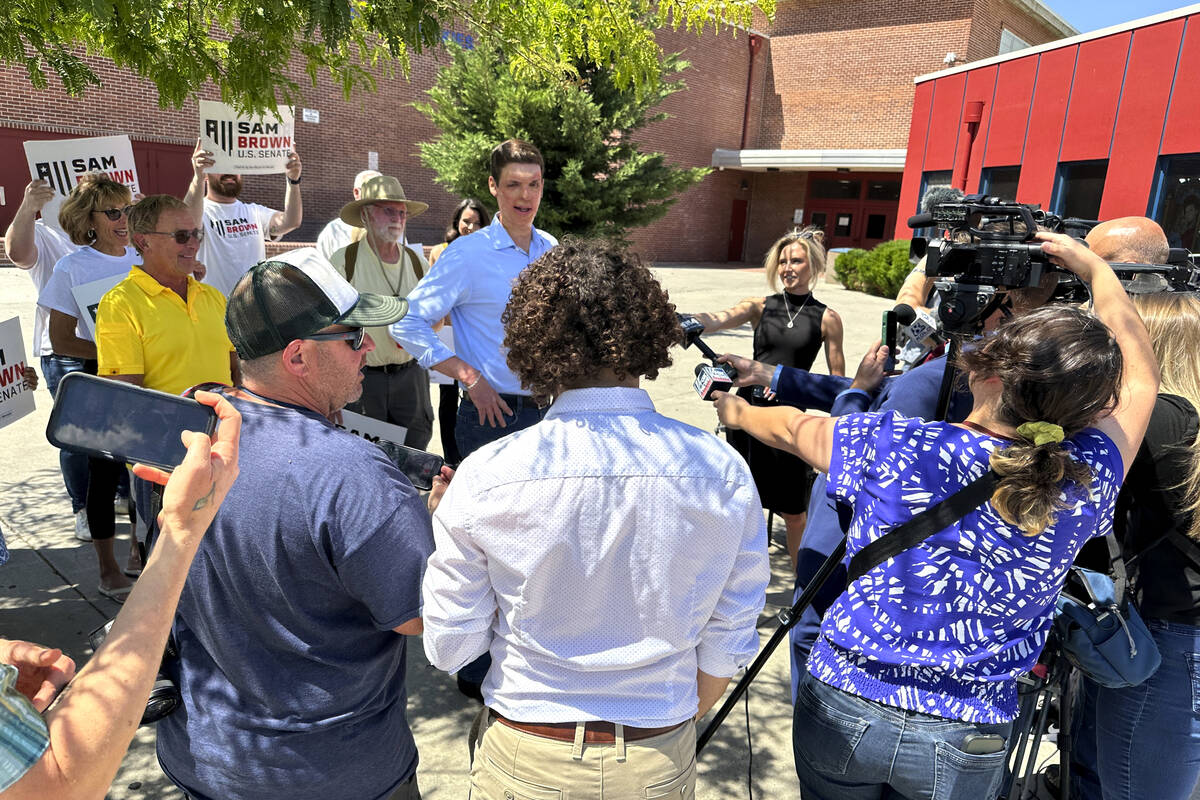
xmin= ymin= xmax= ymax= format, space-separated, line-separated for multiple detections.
xmin=422 ymin=389 xmax=769 ymax=727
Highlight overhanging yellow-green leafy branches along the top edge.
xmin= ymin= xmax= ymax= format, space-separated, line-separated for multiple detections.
xmin=0 ymin=0 xmax=775 ymax=110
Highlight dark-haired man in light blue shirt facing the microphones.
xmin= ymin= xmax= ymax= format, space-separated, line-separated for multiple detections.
xmin=391 ymin=139 xmax=558 ymax=458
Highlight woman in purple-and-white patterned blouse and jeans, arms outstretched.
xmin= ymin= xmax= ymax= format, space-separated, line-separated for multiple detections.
xmin=716 ymin=234 xmax=1158 ymax=800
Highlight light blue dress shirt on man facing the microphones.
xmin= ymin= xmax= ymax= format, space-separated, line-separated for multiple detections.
xmin=389 ymin=216 xmax=558 ymax=395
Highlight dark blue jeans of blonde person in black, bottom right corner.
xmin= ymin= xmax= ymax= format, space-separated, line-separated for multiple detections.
xmin=1072 ymin=619 xmax=1200 ymax=800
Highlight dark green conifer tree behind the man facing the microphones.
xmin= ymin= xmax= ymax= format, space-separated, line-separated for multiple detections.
xmin=416 ymin=44 xmax=712 ymax=240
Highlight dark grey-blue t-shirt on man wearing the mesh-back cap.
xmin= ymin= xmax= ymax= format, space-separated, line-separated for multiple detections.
xmin=158 ymin=399 xmax=433 ymax=800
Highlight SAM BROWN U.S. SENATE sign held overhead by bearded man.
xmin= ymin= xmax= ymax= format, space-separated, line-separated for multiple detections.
xmin=200 ymin=100 xmax=295 ymax=175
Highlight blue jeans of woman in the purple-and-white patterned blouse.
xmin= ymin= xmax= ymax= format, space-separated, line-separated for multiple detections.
xmin=792 ymin=674 xmax=1012 ymax=800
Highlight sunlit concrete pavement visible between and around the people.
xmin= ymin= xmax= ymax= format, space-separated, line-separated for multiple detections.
xmin=0 ymin=265 xmax=892 ymax=800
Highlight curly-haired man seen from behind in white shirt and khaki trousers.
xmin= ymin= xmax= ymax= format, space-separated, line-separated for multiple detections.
xmin=421 ymin=234 xmax=770 ymax=800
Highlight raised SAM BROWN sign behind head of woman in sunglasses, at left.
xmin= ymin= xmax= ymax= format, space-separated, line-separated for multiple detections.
xmin=24 ymin=136 xmax=142 ymax=228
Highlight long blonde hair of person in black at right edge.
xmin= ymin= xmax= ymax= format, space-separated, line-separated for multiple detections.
xmin=1130 ymin=291 xmax=1200 ymax=541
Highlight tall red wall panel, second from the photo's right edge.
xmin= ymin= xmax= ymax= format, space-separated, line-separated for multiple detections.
xmin=1099 ymin=19 xmax=1195 ymax=219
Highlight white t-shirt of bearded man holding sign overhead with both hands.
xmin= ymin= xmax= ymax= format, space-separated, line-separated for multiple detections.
xmin=198 ymin=198 xmax=278 ymax=297
